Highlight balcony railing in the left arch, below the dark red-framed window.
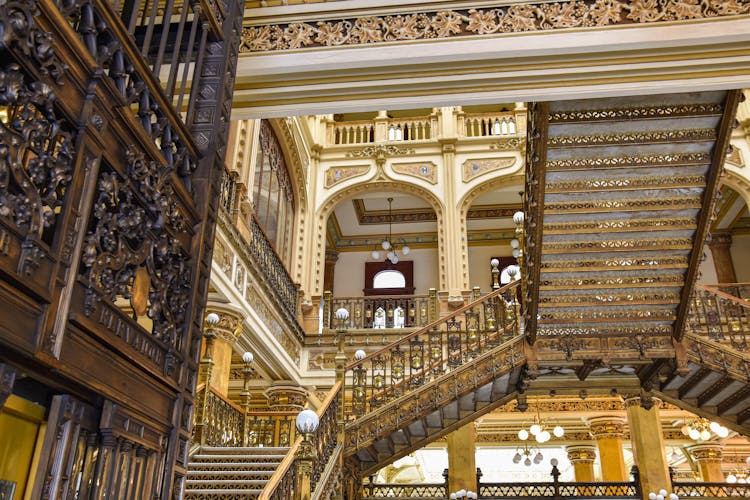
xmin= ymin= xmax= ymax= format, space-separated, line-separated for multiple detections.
xmin=323 ymin=292 xmax=437 ymax=329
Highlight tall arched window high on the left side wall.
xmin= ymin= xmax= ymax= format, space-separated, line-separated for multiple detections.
xmin=253 ymin=120 xmax=294 ymax=261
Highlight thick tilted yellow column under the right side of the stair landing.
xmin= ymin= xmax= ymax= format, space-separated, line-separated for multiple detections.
xmin=625 ymin=396 xmax=672 ymax=498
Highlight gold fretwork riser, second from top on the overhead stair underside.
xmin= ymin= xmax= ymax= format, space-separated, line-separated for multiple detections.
xmin=547 ymin=128 xmax=716 ymax=147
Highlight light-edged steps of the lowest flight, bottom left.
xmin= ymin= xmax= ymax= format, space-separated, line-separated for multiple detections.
xmin=183 ymin=447 xmax=289 ymax=500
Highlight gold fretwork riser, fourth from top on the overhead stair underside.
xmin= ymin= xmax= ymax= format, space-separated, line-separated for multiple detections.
xmin=545 ymin=175 xmax=706 ymax=193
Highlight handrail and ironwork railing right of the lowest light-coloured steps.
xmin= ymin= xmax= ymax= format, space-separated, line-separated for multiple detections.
xmin=258 ymin=382 xmax=342 ymax=500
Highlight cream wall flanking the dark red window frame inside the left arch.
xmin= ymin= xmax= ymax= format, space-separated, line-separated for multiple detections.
xmin=333 ymin=248 xmax=438 ymax=297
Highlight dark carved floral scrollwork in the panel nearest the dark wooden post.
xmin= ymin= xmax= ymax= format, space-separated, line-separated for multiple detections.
xmin=81 ymin=148 xmax=191 ymax=346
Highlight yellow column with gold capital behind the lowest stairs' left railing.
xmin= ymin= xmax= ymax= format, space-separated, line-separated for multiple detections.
xmin=206 ymin=304 xmax=244 ymax=396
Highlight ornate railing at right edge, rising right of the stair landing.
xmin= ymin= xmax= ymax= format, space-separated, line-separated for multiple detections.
xmin=686 ymin=285 xmax=750 ymax=350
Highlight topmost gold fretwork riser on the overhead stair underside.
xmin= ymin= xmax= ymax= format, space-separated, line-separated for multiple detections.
xmin=549 ymin=103 xmax=723 ymax=123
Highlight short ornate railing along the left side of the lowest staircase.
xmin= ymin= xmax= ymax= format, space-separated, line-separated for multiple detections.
xmin=193 ymin=384 xmax=244 ymax=447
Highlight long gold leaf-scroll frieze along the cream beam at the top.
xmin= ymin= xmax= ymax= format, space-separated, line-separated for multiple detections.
xmin=240 ymin=0 xmax=750 ymax=53
